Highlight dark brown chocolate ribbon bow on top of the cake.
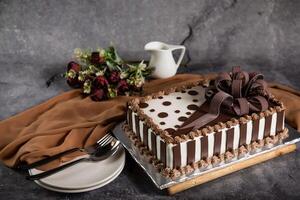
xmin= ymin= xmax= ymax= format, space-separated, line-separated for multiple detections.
xmin=180 ymin=67 xmax=269 ymax=130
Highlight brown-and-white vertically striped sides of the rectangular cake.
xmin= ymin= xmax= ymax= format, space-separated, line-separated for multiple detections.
xmin=127 ymin=108 xmax=284 ymax=169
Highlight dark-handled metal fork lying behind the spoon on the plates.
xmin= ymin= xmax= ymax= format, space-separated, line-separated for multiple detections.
xmin=18 ymin=133 xmax=113 ymax=170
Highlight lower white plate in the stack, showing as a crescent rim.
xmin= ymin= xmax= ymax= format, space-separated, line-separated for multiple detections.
xmin=35 ymin=165 xmax=124 ymax=193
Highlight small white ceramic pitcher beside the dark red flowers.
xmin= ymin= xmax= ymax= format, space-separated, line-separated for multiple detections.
xmin=145 ymin=42 xmax=185 ymax=78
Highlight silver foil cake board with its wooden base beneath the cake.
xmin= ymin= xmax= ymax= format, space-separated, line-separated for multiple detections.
xmin=113 ymin=123 xmax=300 ymax=194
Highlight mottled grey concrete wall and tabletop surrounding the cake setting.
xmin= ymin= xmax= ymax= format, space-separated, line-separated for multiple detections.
xmin=0 ymin=0 xmax=300 ymax=199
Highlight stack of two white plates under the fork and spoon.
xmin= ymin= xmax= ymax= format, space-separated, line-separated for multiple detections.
xmin=29 ymin=146 xmax=125 ymax=193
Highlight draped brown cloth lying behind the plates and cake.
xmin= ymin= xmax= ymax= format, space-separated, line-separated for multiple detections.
xmin=0 ymin=74 xmax=300 ymax=170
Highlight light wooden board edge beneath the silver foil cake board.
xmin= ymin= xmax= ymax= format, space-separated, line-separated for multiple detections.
xmin=167 ymin=144 xmax=297 ymax=195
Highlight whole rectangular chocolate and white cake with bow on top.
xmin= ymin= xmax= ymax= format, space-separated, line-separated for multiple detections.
xmin=124 ymin=67 xmax=288 ymax=177
